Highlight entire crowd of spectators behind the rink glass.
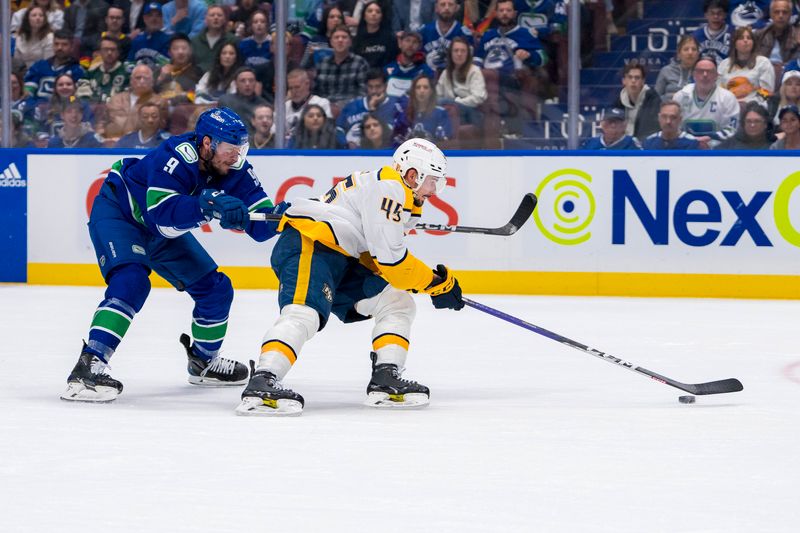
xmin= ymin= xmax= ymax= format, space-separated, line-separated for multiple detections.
xmin=8 ymin=0 xmax=800 ymax=150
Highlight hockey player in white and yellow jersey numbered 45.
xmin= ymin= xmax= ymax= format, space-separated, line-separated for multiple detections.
xmin=236 ymin=139 xmax=464 ymax=415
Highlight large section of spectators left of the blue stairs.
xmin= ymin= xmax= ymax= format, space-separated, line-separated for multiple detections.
xmin=1 ymin=0 xmax=564 ymax=149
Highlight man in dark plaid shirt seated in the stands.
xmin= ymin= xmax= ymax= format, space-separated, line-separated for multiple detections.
xmin=315 ymin=24 xmax=369 ymax=108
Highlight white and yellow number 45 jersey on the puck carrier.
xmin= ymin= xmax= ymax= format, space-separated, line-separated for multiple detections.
xmin=280 ymin=166 xmax=433 ymax=290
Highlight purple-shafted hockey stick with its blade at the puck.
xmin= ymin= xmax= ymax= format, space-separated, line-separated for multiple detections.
xmin=464 ymin=298 xmax=744 ymax=396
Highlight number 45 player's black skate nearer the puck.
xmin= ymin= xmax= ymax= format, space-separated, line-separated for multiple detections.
xmin=364 ymin=352 xmax=431 ymax=409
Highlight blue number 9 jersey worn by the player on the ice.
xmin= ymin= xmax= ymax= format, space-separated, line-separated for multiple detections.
xmin=107 ymin=132 xmax=273 ymax=242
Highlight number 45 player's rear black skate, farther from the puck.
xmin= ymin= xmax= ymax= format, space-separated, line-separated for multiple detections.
xmin=236 ymin=361 xmax=305 ymax=416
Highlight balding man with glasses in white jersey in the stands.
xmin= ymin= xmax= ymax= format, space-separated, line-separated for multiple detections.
xmin=672 ymin=56 xmax=740 ymax=148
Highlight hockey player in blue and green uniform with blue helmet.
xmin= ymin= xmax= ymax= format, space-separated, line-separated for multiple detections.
xmin=61 ymin=108 xmax=288 ymax=402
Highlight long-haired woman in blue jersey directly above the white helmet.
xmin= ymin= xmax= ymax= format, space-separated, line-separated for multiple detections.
xmin=394 ymin=74 xmax=453 ymax=144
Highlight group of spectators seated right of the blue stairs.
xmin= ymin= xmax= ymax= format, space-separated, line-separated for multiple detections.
xmin=583 ymin=0 xmax=800 ymax=150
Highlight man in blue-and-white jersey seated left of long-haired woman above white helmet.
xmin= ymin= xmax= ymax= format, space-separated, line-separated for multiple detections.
xmin=336 ymin=69 xmax=403 ymax=148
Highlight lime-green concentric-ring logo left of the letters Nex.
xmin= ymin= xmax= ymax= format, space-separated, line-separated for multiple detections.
xmin=533 ymin=168 xmax=595 ymax=246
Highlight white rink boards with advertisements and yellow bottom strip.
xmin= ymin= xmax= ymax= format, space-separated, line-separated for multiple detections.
xmin=0 ymin=150 xmax=800 ymax=298
